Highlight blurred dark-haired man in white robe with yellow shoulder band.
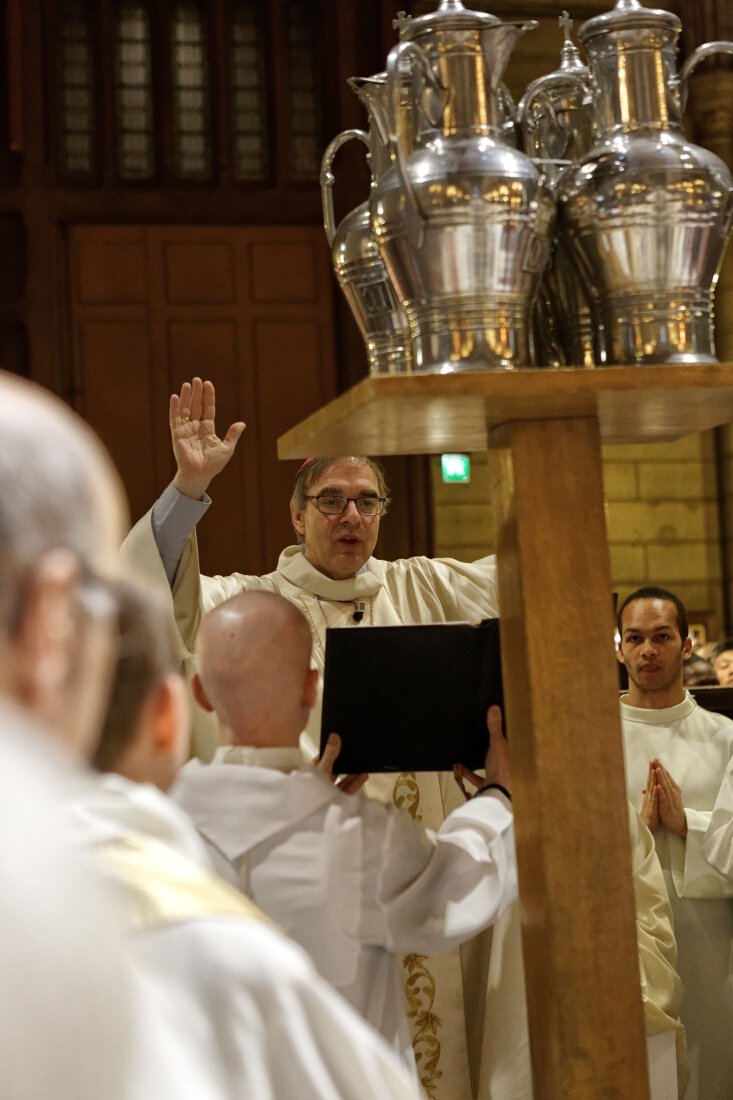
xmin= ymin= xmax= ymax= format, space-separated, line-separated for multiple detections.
xmin=70 ymin=584 xmax=418 ymax=1100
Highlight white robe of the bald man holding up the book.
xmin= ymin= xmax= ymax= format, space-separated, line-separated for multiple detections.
xmin=174 ymin=747 xmax=516 ymax=1078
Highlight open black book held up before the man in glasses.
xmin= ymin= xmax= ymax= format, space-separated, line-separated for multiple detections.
xmin=320 ymin=619 xmax=503 ymax=774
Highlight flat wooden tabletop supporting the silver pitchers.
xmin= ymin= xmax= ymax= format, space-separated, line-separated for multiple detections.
xmin=277 ymin=363 xmax=733 ymax=459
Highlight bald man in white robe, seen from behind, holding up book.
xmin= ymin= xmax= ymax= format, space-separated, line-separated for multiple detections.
xmin=174 ymin=592 xmax=516 ymax=1078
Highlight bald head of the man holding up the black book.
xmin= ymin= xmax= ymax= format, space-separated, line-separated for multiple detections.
xmin=194 ymin=592 xmax=317 ymax=745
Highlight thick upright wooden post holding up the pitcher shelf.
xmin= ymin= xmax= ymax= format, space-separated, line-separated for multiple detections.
xmin=491 ymin=419 xmax=648 ymax=1100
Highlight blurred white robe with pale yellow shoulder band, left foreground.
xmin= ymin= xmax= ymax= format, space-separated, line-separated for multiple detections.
xmin=70 ymin=776 xmax=418 ymax=1100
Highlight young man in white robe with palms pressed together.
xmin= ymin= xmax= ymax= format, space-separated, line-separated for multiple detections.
xmin=617 ymin=587 xmax=733 ymax=1100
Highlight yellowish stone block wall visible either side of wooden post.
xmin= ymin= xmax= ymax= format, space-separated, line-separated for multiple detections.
xmin=424 ymin=432 xmax=721 ymax=633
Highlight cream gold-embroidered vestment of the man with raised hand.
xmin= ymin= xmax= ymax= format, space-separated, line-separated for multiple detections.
xmin=123 ymin=509 xmax=499 ymax=1100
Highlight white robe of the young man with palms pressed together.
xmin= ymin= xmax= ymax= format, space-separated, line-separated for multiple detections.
xmin=621 ymin=693 xmax=733 ymax=1100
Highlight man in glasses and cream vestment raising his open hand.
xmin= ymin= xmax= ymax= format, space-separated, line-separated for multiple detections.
xmin=123 ymin=378 xmax=497 ymax=1100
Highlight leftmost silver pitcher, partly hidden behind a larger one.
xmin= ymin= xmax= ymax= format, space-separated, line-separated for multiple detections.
xmin=320 ymin=73 xmax=413 ymax=374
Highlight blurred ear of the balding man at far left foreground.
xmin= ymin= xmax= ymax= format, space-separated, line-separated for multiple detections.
xmin=12 ymin=549 xmax=79 ymax=725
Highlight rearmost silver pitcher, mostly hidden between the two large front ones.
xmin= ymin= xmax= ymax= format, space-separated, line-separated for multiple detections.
xmin=517 ymin=12 xmax=605 ymax=367
